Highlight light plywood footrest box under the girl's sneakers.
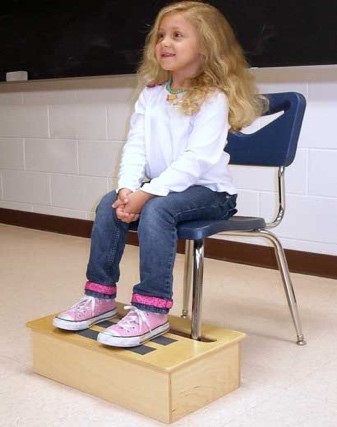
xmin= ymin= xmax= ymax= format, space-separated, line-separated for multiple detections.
xmin=27 ymin=307 xmax=244 ymax=423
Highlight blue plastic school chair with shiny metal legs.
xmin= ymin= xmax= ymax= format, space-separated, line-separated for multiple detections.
xmin=178 ymin=92 xmax=306 ymax=345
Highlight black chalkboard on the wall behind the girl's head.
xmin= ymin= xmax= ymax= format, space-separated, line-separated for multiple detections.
xmin=0 ymin=0 xmax=337 ymax=81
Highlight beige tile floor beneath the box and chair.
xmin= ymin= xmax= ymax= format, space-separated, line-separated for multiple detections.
xmin=0 ymin=224 xmax=337 ymax=427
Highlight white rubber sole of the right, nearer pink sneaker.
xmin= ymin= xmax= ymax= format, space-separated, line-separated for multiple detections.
xmin=97 ymin=322 xmax=170 ymax=348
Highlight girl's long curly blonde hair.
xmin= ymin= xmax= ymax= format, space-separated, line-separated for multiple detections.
xmin=138 ymin=1 xmax=266 ymax=131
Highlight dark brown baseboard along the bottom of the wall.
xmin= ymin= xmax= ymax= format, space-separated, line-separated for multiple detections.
xmin=0 ymin=208 xmax=337 ymax=279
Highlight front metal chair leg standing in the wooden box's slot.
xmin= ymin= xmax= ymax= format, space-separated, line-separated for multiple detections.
xmin=191 ymin=240 xmax=204 ymax=340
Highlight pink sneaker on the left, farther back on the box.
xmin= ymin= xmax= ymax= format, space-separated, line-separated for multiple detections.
xmin=53 ymin=295 xmax=116 ymax=331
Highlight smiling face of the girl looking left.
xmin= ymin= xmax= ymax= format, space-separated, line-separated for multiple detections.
xmin=155 ymin=14 xmax=201 ymax=85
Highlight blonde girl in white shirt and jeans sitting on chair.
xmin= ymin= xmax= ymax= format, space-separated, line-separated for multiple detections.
xmin=53 ymin=1 xmax=262 ymax=347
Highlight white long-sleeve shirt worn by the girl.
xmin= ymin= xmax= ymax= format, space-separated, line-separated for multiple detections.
xmin=118 ymin=85 xmax=237 ymax=196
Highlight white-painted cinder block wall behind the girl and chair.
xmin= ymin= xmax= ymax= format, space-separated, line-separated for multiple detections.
xmin=0 ymin=66 xmax=337 ymax=255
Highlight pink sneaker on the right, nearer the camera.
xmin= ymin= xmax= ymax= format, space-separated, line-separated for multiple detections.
xmin=97 ymin=306 xmax=170 ymax=347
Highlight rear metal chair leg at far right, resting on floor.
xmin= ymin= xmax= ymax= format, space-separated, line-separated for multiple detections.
xmin=257 ymin=230 xmax=306 ymax=345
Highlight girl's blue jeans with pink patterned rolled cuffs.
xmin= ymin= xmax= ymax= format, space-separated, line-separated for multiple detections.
xmin=86 ymin=186 xmax=237 ymax=313
